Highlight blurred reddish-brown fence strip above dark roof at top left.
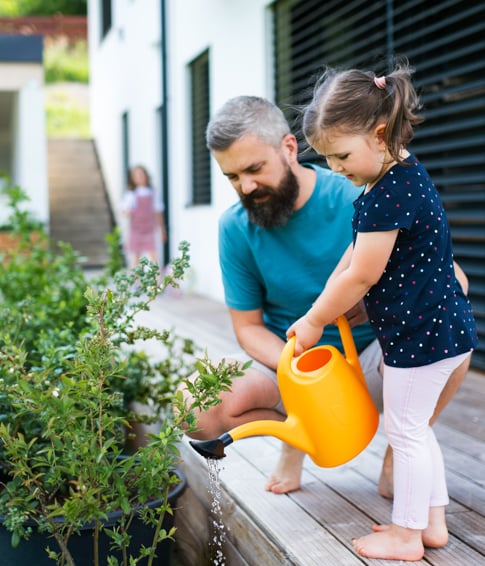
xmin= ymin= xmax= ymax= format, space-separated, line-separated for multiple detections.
xmin=0 ymin=14 xmax=88 ymax=42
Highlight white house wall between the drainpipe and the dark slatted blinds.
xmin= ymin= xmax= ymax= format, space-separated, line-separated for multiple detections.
xmin=167 ymin=0 xmax=271 ymax=301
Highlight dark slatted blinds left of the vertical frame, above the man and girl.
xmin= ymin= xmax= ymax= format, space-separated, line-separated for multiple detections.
xmin=273 ymin=0 xmax=386 ymax=165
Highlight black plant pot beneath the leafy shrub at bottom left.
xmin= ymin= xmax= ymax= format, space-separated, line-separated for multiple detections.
xmin=0 ymin=470 xmax=187 ymax=566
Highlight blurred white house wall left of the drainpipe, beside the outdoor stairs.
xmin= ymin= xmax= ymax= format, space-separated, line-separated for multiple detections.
xmin=88 ymin=0 xmax=161 ymax=229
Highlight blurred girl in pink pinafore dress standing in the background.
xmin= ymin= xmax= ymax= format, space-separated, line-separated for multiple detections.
xmin=122 ymin=165 xmax=167 ymax=267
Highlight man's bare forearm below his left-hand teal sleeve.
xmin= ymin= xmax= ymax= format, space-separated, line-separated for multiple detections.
xmin=229 ymin=309 xmax=285 ymax=369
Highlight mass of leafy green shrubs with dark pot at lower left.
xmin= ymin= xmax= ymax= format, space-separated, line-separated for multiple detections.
xmin=0 ymin=182 xmax=240 ymax=566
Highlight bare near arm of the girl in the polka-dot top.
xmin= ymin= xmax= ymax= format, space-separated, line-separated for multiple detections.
xmin=286 ymin=230 xmax=398 ymax=356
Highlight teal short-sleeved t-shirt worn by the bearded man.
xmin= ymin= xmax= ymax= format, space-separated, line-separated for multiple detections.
xmin=219 ymin=164 xmax=375 ymax=351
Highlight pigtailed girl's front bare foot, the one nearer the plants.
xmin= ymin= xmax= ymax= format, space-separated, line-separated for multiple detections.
xmin=352 ymin=525 xmax=424 ymax=562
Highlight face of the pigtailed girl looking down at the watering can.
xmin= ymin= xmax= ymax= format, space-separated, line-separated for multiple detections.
xmin=313 ymin=126 xmax=392 ymax=189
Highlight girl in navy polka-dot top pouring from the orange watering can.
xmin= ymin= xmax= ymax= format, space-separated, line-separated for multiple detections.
xmin=287 ymin=64 xmax=477 ymax=560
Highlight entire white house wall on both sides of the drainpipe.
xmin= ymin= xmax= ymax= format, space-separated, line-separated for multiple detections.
xmin=88 ymin=0 xmax=272 ymax=301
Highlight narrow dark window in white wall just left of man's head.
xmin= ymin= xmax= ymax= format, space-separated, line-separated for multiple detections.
xmin=190 ymin=50 xmax=211 ymax=204
